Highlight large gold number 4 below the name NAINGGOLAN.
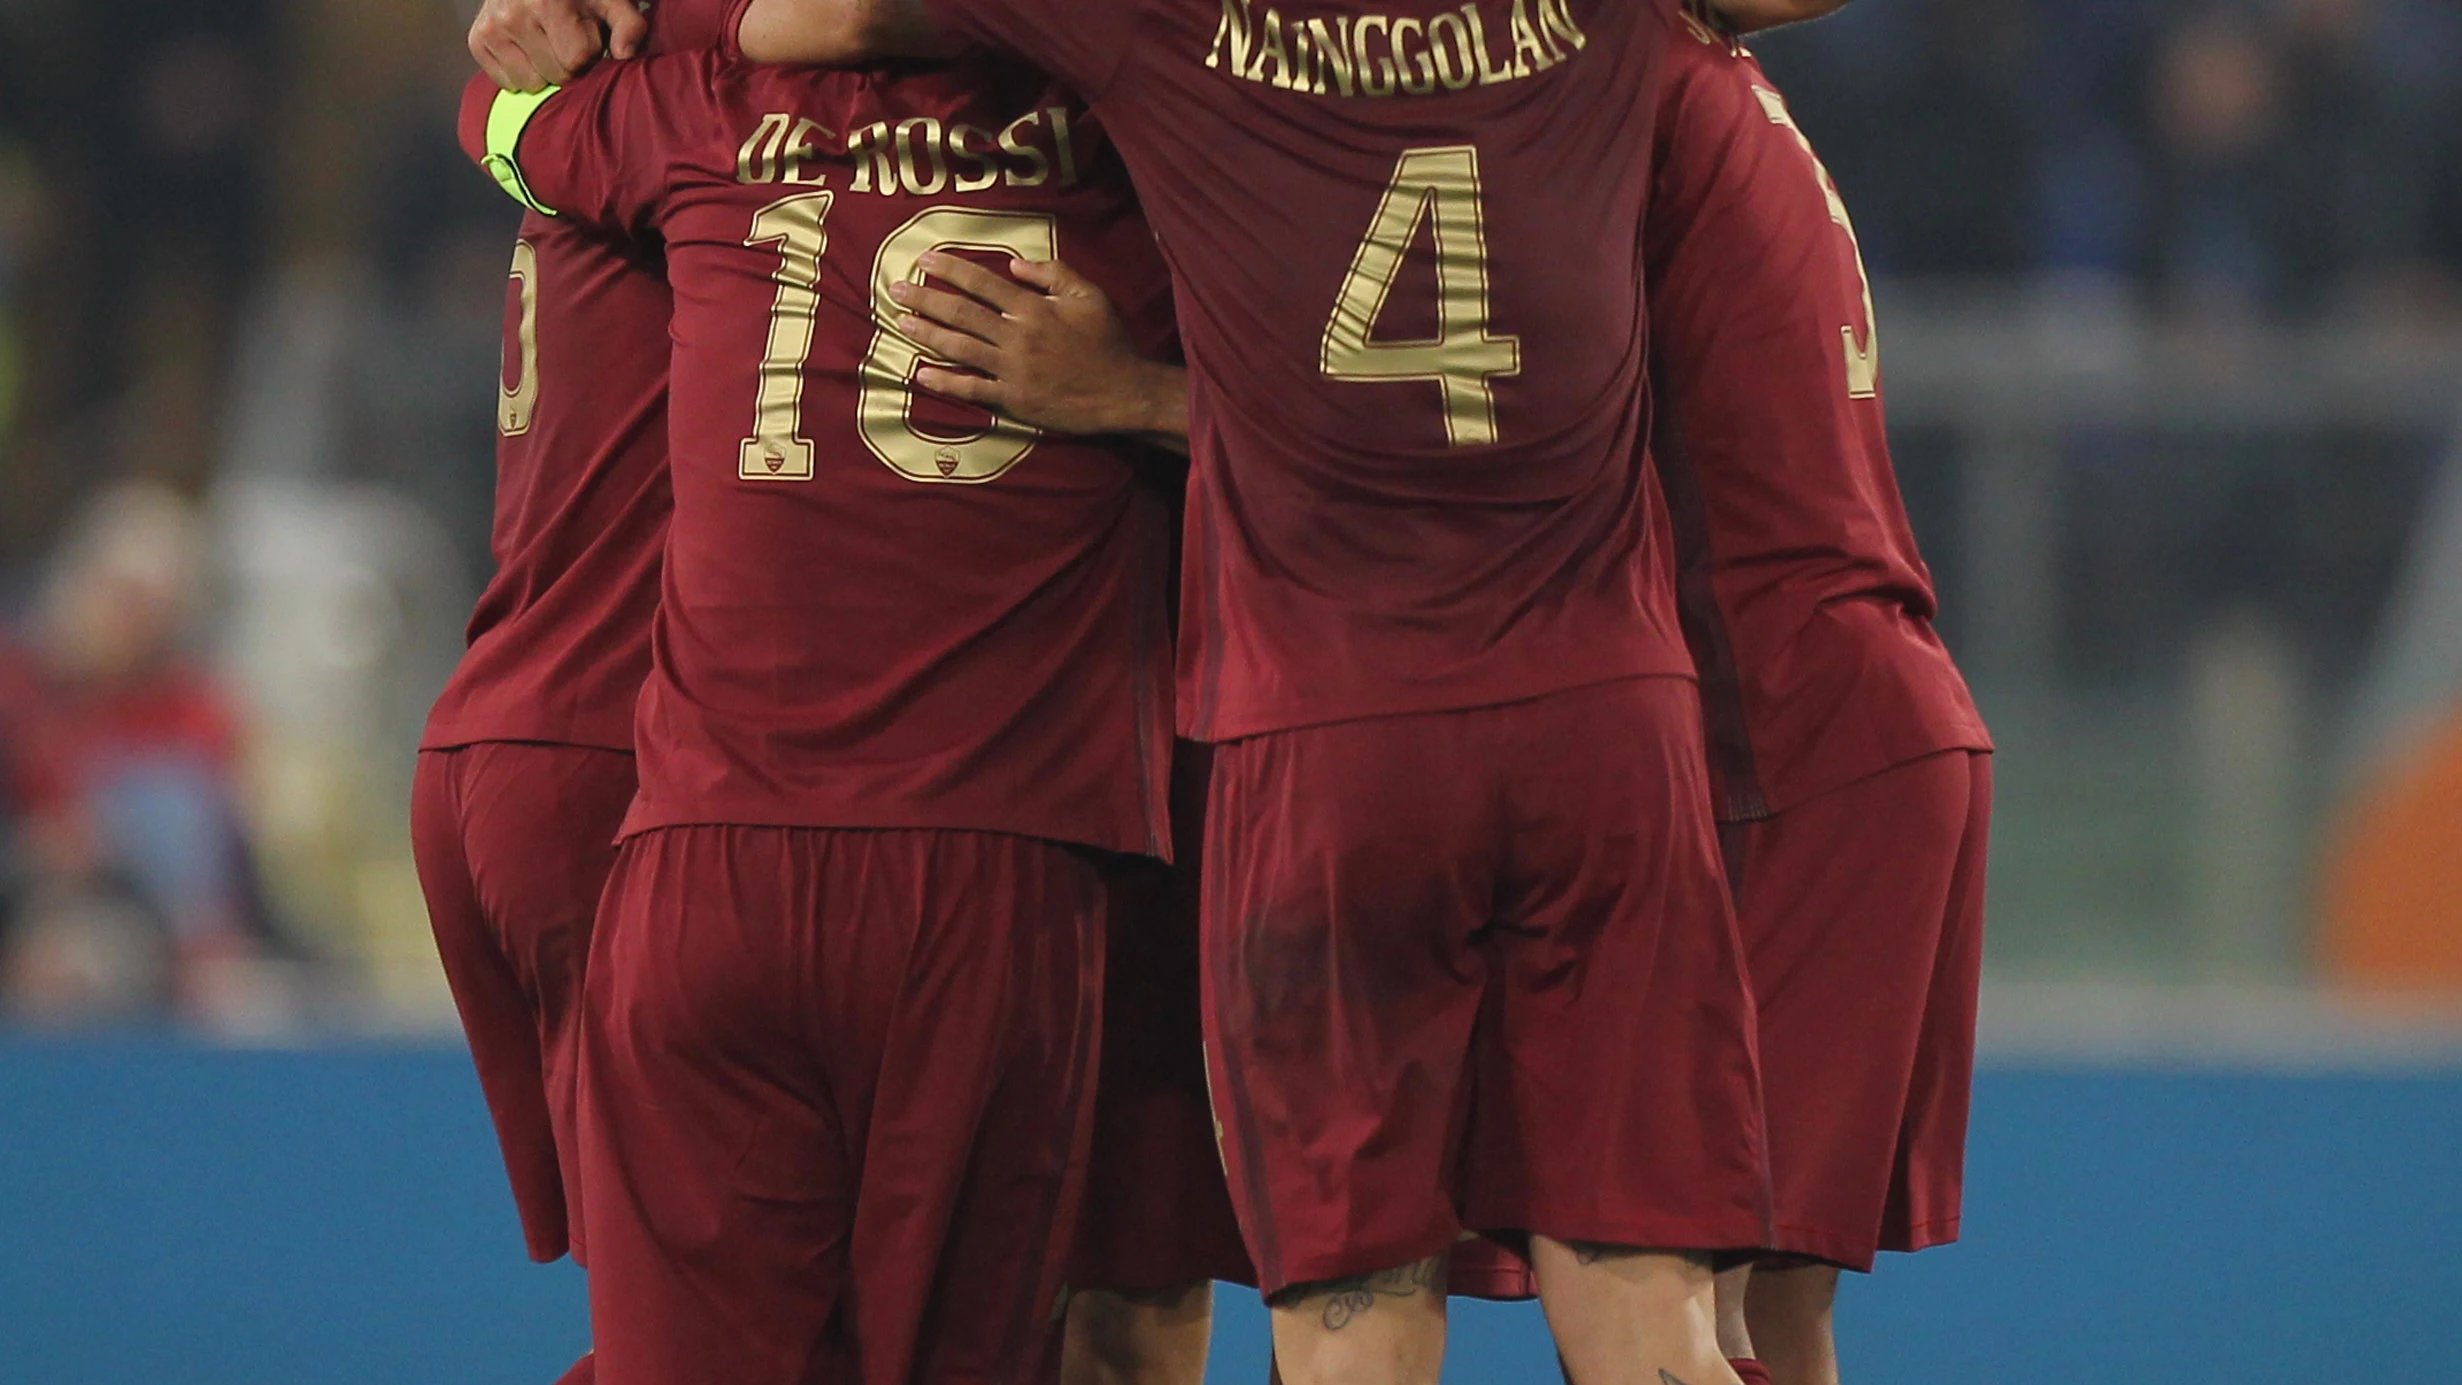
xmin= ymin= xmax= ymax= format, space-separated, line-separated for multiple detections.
xmin=1320 ymin=145 xmax=1522 ymax=448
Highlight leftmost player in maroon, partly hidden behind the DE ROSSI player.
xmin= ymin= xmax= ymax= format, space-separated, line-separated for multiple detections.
xmin=411 ymin=214 xmax=670 ymax=1298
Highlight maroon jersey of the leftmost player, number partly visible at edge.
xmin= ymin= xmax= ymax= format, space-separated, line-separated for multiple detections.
xmin=419 ymin=214 xmax=667 ymax=750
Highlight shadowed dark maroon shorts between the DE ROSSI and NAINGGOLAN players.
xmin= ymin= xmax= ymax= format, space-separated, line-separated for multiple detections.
xmin=1069 ymin=743 xmax=1256 ymax=1294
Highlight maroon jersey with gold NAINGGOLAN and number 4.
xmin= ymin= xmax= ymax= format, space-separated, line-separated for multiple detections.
xmin=928 ymin=0 xmax=1691 ymax=740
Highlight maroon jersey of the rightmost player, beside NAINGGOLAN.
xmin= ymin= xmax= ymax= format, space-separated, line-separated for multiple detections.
xmin=1647 ymin=20 xmax=1992 ymax=819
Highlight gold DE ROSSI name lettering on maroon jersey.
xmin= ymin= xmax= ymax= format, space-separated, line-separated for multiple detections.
xmin=736 ymin=106 xmax=1081 ymax=197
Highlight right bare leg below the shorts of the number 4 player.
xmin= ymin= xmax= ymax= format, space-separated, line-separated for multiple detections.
xmin=1531 ymin=1235 xmax=1741 ymax=1385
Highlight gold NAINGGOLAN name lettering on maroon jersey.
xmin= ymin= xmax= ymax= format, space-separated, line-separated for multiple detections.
xmin=1206 ymin=0 xmax=1590 ymax=96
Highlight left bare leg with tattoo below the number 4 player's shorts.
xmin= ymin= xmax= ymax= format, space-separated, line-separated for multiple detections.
xmin=1273 ymin=1255 xmax=1448 ymax=1385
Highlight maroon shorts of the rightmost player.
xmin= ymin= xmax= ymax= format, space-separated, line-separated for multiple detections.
xmin=1728 ymin=750 xmax=1992 ymax=1269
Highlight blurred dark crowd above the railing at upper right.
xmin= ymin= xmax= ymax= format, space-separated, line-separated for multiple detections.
xmin=1765 ymin=0 xmax=2462 ymax=320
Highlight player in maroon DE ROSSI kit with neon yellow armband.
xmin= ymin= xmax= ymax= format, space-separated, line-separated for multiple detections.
xmin=463 ymin=54 xmax=1191 ymax=1385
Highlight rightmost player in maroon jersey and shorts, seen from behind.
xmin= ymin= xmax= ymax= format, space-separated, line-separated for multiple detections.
xmin=1647 ymin=8 xmax=1992 ymax=1385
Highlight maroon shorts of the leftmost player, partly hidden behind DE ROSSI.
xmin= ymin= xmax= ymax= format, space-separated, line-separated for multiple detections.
xmin=411 ymin=740 xmax=633 ymax=1260
